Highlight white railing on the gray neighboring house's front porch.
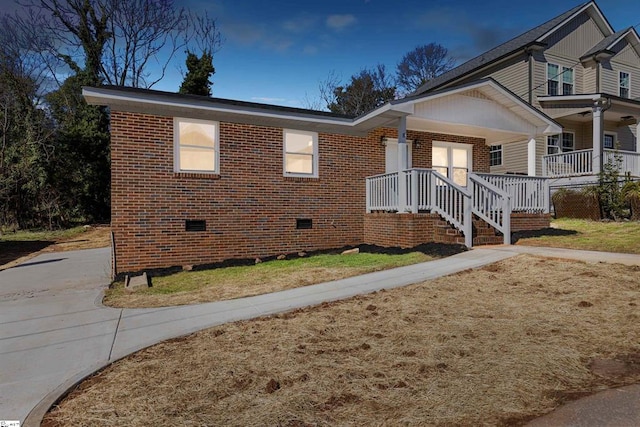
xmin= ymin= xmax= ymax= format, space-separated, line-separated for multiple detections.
xmin=542 ymin=149 xmax=640 ymax=178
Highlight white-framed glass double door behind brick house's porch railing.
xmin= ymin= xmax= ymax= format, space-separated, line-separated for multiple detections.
xmin=431 ymin=141 xmax=473 ymax=187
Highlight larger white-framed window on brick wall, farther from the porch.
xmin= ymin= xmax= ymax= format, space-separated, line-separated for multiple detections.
xmin=173 ymin=118 xmax=219 ymax=173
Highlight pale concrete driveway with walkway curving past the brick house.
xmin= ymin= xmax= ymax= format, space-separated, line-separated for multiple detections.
xmin=0 ymin=246 xmax=640 ymax=426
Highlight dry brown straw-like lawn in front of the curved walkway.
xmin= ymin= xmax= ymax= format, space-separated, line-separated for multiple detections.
xmin=46 ymin=255 xmax=640 ymax=426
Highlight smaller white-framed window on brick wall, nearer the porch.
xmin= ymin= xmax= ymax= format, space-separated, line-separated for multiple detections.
xmin=283 ymin=129 xmax=318 ymax=178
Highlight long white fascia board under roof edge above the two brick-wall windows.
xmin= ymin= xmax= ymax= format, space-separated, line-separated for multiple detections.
xmin=82 ymin=88 xmax=353 ymax=127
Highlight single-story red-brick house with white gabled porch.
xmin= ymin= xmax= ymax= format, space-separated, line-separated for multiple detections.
xmin=83 ymin=79 xmax=561 ymax=275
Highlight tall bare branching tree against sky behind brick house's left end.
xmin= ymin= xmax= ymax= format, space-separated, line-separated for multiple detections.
xmin=23 ymin=0 xmax=221 ymax=88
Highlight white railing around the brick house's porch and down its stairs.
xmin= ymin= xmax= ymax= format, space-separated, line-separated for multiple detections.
xmin=366 ymin=169 xmax=520 ymax=247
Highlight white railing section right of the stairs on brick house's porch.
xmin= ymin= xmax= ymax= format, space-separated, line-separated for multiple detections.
xmin=476 ymin=173 xmax=549 ymax=213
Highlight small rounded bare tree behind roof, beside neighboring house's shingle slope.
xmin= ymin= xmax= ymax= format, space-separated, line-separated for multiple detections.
xmin=396 ymin=43 xmax=455 ymax=93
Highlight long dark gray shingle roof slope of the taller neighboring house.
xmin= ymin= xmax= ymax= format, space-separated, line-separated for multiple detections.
xmin=412 ymin=2 xmax=591 ymax=95
